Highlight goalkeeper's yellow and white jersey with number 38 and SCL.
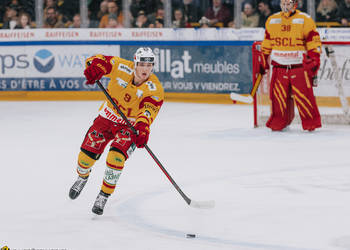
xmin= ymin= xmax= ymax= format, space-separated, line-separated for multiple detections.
xmin=261 ymin=10 xmax=321 ymax=65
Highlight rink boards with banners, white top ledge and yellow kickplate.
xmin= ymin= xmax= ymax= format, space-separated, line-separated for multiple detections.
xmin=0 ymin=29 xmax=350 ymax=106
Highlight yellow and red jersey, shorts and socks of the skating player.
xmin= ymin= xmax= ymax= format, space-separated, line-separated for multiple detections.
xmin=77 ymin=55 xmax=164 ymax=194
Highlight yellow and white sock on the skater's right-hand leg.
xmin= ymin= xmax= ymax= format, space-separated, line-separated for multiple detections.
xmin=101 ymin=150 xmax=125 ymax=194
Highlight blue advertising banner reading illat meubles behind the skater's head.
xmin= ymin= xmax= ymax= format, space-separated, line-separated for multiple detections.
xmin=121 ymin=45 xmax=252 ymax=94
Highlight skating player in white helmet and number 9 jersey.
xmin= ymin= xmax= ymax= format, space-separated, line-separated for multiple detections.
xmin=69 ymin=47 xmax=164 ymax=215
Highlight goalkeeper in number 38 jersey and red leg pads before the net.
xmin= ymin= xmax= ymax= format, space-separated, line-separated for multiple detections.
xmin=259 ymin=0 xmax=321 ymax=131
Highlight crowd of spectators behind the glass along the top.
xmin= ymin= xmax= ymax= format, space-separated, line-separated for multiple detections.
xmin=0 ymin=0 xmax=350 ymax=29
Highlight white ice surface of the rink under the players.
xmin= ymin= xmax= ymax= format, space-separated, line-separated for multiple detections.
xmin=0 ymin=102 xmax=350 ymax=250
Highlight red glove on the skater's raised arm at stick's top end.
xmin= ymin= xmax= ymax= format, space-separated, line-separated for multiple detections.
xmin=84 ymin=58 xmax=112 ymax=84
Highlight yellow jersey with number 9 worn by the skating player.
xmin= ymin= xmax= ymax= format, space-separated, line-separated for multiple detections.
xmin=86 ymin=55 xmax=164 ymax=128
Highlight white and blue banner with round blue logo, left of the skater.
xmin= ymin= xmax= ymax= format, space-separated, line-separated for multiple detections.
xmin=0 ymin=45 xmax=120 ymax=91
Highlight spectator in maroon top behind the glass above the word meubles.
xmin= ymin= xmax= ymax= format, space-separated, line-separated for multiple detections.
xmin=204 ymin=0 xmax=232 ymax=27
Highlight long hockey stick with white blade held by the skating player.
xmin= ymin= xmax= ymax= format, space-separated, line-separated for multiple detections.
xmin=96 ymin=81 xmax=215 ymax=208
